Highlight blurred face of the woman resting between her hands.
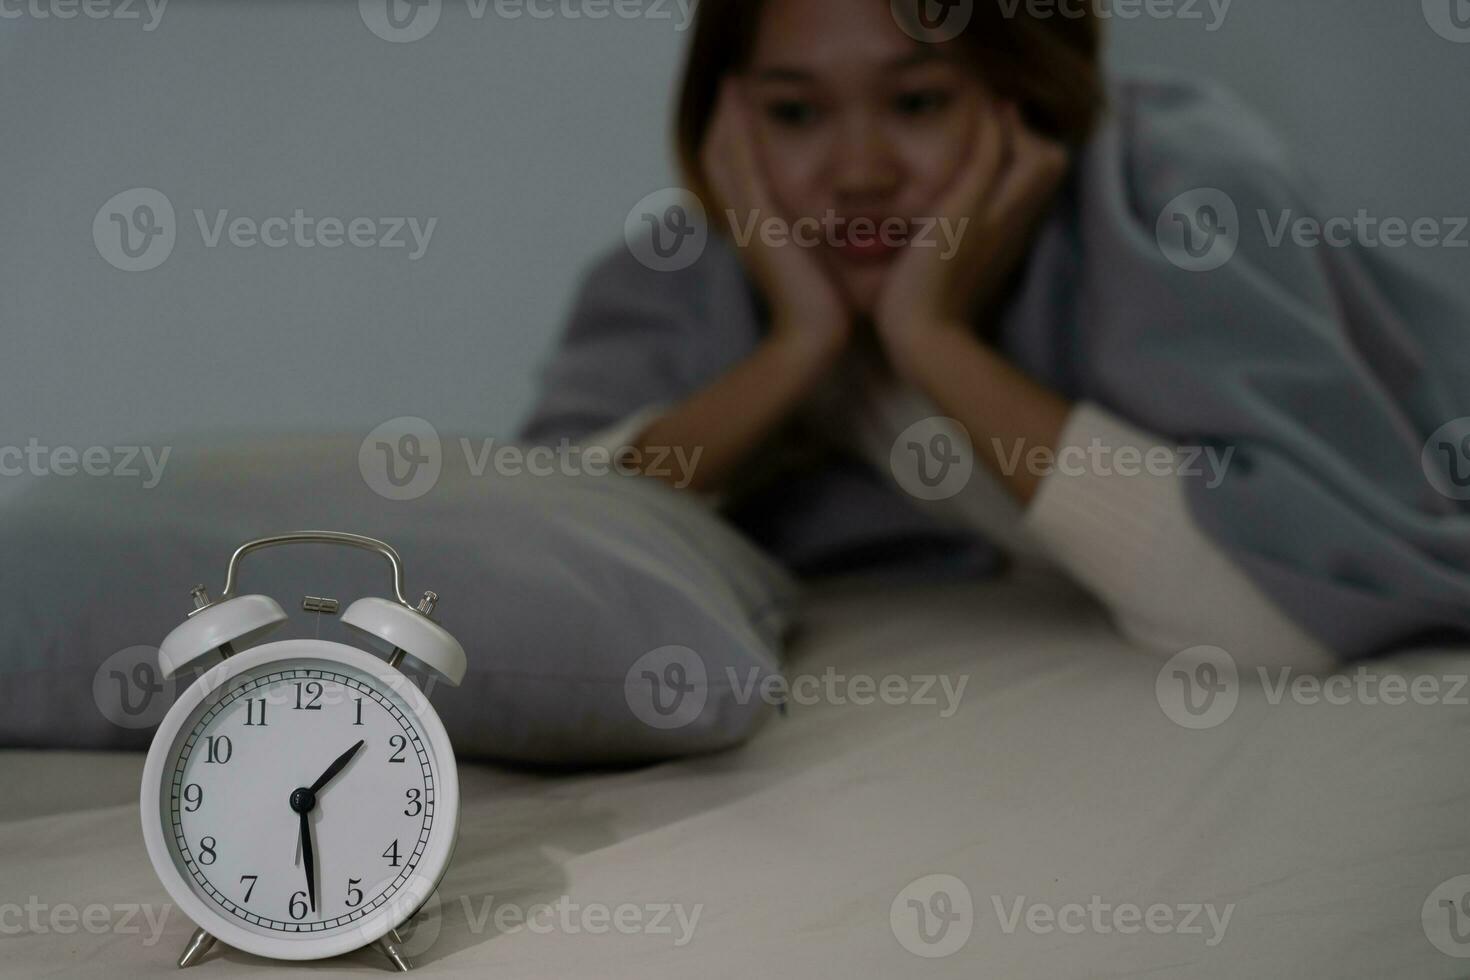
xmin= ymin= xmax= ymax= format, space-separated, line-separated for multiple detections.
xmin=738 ymin=0 xmax=989 ymax=313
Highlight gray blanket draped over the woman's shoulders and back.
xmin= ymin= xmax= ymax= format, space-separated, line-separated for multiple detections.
xmin=526 ymin=79 xmax=1470 ymax=655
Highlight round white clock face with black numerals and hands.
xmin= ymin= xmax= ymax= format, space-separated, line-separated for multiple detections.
xmin=159 ymin=651 xmax=441 ymax=939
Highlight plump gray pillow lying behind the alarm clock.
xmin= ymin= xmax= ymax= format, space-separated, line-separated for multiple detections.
xmin=0 ymin=436 xmax=795 ymax=764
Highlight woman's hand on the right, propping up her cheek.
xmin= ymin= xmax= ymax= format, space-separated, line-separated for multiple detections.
xmin=873 ymin=101 xmax=1069 ymax=376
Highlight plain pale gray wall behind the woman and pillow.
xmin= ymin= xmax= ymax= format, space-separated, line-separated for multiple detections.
xmin=0 ymin=0 xmax=1470 ymax=461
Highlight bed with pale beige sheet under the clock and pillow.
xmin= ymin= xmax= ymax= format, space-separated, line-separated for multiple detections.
xmin=0 ymin=576 xmax=1470 ymax=979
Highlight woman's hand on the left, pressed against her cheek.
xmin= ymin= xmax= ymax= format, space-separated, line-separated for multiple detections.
xmin=700 ymin=79 xmax=853 ymax=360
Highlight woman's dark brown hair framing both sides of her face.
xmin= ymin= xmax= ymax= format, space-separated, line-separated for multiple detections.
xmin=675 ymin=0 xmax=1105 ymax=200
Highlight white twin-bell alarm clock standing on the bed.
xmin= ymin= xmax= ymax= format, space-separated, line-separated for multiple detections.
xmin=141 ymin=530 xmax=465 ymax=970
